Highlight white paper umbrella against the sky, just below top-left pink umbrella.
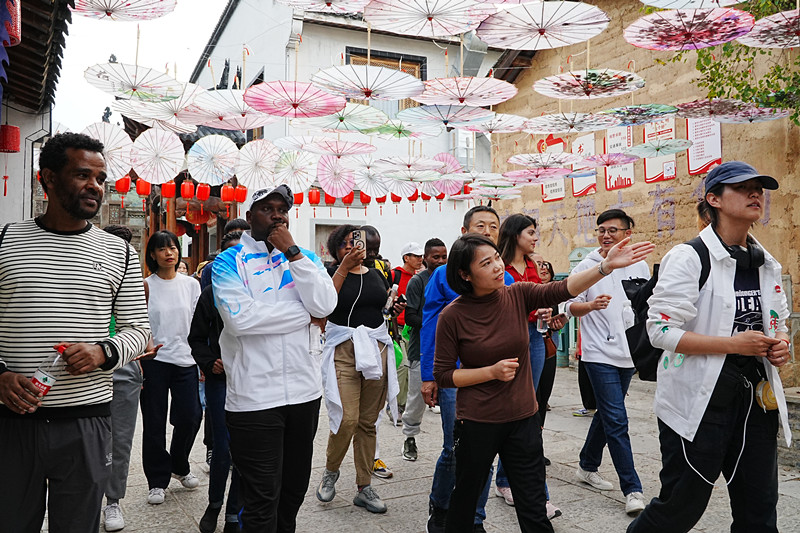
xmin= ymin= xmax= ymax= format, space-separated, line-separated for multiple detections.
xmin=83 ymin=63 xmax=184 ymax=102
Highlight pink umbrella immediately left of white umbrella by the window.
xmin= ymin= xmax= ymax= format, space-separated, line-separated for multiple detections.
xmin=244 ymin=81 xmax=347 ymax=118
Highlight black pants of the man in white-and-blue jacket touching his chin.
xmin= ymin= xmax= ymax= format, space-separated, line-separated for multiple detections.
xmin=225 ymin=398 xmax=320 ymax=533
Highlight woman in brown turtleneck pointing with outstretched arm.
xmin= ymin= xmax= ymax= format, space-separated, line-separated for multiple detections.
xmin=434 ymin=234 xmax=654 ymax=533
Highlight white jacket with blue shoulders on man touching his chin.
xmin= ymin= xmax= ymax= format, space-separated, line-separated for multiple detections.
xmin=212 ymin=233 xmax=338 ymax=412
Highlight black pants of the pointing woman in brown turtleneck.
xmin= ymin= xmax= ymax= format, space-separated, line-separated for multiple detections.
xmin=445 ymin=415 xmax=553 ymax=533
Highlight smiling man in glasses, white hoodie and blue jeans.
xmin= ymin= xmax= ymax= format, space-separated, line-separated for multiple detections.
xmin=566 ymin=209 xmax=650 ymax=515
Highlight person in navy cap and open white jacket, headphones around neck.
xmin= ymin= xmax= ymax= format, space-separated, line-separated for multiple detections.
xmin=628 ymin=161 xmax=791 ymax=533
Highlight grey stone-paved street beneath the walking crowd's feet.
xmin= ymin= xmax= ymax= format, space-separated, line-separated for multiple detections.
xmin=83 ymin=368 xmax=800 ymax=533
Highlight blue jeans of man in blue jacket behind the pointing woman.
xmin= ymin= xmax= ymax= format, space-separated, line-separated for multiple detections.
xmin=430 ymin=389 xmax=492 ymax=524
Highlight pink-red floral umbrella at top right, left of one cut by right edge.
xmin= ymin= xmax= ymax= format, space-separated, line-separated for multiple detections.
xmin=623 ymin=8 xmax=755 ymax=50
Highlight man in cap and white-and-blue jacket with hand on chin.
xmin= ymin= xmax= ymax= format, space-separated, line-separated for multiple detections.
xmin=212 ymin=185 xmax=337 ymax=532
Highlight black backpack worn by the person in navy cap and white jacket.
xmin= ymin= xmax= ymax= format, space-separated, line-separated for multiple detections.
xmin=622 ymin=237 xmax=711 ymax=381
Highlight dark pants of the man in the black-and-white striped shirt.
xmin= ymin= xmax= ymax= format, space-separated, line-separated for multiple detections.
xmin=0 ymin=416 xmax=111 ymax=533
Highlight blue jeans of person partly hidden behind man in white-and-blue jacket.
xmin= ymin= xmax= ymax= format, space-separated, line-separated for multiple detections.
xmin=206 ymin=378 xmax=240 ymax=515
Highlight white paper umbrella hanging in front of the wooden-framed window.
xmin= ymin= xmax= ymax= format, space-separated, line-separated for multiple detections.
xmin=311 ymin=64 xmax=424 ymax=100
